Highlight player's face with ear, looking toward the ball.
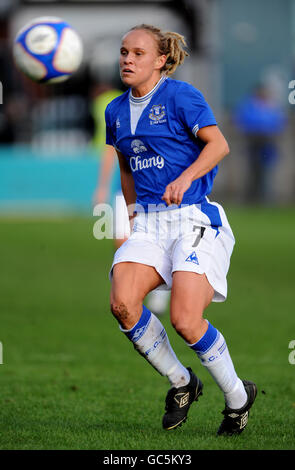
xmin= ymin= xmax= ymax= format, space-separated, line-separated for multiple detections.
xmin=120 ymin=29 xmax=166 ymax=93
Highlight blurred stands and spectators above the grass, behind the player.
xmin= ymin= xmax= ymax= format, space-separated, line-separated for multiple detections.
xmin=0 ymin=0 xmax=295 ymax=215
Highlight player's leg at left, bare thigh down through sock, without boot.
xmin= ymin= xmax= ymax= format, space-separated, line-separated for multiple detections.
xmin=111 ymin=262 xmax=190 ymax=387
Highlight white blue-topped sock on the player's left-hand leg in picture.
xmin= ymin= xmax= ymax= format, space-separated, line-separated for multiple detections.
xmin=120 ymin=306 xmax=190 ymax=388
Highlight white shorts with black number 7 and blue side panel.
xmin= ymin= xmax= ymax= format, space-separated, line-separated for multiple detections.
xmin=110 ymin=199 xmax=235 ymax=302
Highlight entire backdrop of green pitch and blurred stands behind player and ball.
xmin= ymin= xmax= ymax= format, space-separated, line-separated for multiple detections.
xmin=0 ymin=0 xmax=295 ymax=456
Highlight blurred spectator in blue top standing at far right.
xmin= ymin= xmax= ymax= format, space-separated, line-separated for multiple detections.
xmin=234 ymin=85 xmax=286 ymax=203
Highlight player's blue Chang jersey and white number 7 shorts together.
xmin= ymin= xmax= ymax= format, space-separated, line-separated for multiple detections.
xmin=105 ymin=76 xmax=235 ymax=301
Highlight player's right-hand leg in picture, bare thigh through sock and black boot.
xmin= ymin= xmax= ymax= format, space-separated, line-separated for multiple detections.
xmin=171 ymin=271 xmax=256 ymax=434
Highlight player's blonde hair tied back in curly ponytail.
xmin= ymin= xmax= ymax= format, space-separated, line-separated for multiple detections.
xmin=130 ymin=23 xmax=189 ymax=76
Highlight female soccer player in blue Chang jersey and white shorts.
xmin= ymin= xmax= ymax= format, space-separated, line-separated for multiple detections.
xmin=105 ymin=24 xmax=257 ymax=435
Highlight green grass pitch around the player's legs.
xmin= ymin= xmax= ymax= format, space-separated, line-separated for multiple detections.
xmin=0 ymin=208 xmax=295 ymax=450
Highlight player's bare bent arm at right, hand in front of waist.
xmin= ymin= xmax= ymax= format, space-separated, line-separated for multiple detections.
xmin=162 ymin=125 xmax=229 ymax=206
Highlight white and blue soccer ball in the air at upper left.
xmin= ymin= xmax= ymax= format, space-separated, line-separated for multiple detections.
xmin=13 ymin=17 xmax=83 ymax=83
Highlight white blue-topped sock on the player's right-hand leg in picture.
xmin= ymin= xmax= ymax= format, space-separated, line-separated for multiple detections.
xmin=189 ymin=322 xmax=248 ymax=409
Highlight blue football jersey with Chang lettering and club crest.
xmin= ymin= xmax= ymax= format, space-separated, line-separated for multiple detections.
xmin=105 ymin=78 xmax=218 ymax=209
